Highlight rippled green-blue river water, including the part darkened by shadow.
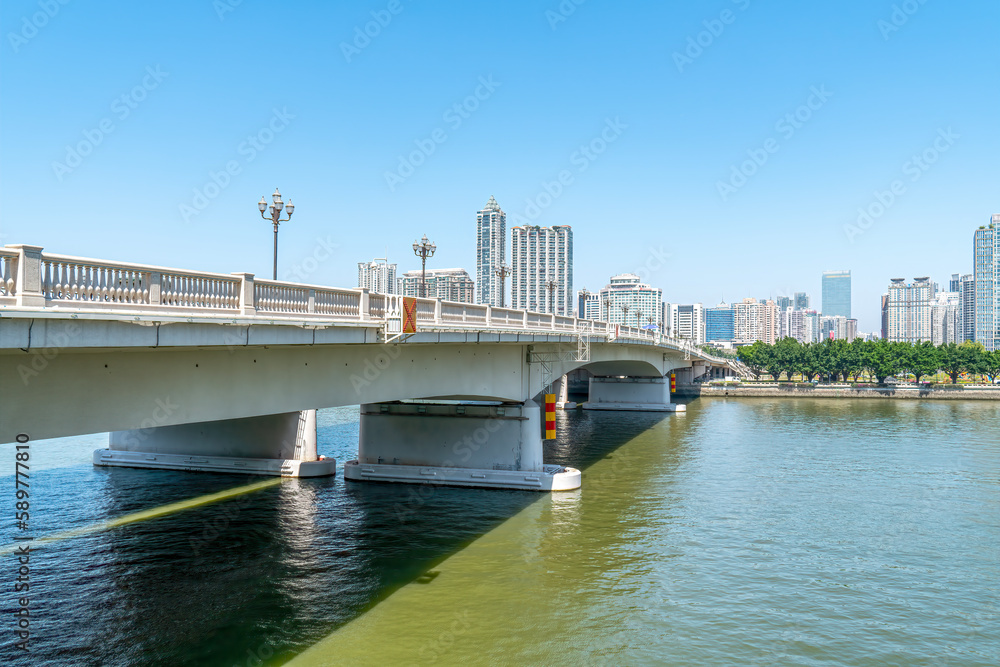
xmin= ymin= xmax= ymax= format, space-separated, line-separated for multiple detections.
xmin=0 ymin=399 xmax=1000 ymax=665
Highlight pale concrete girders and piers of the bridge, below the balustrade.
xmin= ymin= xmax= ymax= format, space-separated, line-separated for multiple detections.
xmin=0 ymin=319 xmax=728 ymax=491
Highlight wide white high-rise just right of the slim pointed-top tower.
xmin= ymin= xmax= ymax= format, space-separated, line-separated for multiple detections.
xmin=510 ymin=225 xmax=573 ymax=315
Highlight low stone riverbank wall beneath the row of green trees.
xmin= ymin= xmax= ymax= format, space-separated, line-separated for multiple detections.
xmin=674 ymin=383 xmax=1000 ymax=401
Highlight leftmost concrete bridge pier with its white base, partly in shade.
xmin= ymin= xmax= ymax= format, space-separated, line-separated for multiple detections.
xmin=94 ymin=410 xmax=337 ymax=477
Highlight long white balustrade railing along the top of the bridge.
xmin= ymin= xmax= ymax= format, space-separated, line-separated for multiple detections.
xmin=0 ymin=245 xmax=748 ymax=370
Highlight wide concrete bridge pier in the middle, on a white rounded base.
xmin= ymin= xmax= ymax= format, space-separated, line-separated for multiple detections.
xmin=344 ymin=400 xmax=580 ymax=491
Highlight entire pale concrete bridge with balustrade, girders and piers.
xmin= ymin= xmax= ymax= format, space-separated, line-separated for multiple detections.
xmin=0 ymin=245 xmax=745 ymax=490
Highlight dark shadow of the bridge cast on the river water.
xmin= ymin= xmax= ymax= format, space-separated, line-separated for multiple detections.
xmin=0 ymin=404 xmax=668 ymax=665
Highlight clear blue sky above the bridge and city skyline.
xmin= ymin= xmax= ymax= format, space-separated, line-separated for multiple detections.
xmin=0 ymin=0 xmax=1000 ymax=331
